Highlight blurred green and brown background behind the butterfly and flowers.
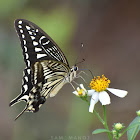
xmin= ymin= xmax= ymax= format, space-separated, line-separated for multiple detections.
xmin=0 ymin=0 xmax=140 ymax=140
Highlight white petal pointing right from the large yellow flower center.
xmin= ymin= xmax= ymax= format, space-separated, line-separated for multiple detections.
xmin=107 ymin=88 xmax=128 ymax=98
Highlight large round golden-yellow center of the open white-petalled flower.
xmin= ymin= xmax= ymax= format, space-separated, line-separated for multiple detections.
xmin=90 ymin=75 xmax=110 ymax=92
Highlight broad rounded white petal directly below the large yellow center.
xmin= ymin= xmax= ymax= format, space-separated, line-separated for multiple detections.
xmin=99 ymin=91 xmax=110 ymax=105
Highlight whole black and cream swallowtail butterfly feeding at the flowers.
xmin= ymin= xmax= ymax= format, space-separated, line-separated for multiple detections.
xmin=9 ymin=19 xmax=78 ymax=120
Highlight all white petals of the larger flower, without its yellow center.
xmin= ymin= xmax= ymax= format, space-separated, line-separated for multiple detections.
xmin=87 ymin=88 xmax=128 ymax=113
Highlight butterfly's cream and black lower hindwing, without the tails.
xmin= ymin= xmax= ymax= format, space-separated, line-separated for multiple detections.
xmin=16 ymin=60 xmax=68 ymax=115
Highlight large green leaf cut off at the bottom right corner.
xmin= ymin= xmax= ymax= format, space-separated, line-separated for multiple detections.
xmin=127 ymin=116 xmax=140 ymax=140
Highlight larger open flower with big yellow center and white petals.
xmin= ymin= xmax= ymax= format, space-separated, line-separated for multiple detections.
xmin=87 ymin=75 xmax=128 ymax=112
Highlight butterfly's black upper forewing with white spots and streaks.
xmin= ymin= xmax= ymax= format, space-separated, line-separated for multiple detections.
xmin=15 ymin=19 xmax=68 ymax=66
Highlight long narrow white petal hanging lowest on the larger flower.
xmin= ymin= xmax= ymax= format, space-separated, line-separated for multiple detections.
xmin=89 ymin=92 xmax=99 ymax=113
